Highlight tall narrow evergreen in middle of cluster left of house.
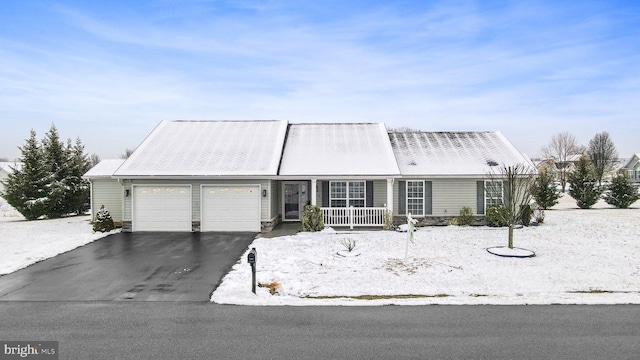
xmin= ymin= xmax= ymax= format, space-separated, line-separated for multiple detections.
xmin=42 ymin=124 xmax=69 ymax=218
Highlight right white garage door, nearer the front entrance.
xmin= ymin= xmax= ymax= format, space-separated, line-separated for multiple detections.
xmin=200 ymin=185 xmax=260 ymax=231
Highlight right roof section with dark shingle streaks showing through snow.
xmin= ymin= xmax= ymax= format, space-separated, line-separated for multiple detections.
xmin=389 ymin=131 xmax=535 ymax=176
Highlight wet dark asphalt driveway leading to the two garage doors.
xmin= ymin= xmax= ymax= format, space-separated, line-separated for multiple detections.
xmin=0 ymin=233 xmax=256 ymax=301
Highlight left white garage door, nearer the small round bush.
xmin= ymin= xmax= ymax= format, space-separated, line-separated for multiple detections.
xmin=133 ymin=185 xmax=191 ymax=231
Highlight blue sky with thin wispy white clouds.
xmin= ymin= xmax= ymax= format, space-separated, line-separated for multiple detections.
xmin=0 ymin=0 xmax=640 ymax=159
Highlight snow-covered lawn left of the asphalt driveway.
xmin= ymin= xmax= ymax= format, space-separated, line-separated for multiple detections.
xmin=0 ymin=202 xmax=119 ymax=275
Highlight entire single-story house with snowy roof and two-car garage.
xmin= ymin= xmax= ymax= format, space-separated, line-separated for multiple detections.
xmin=86 ymin=120 xmax=535 ymax=232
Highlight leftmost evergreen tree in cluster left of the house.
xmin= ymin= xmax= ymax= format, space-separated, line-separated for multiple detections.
xmin=2 ymin=130 xmax=49 ymax=220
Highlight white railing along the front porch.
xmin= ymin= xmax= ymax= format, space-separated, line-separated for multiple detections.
xmin=321 ymin=206 xmax=387 ymax=229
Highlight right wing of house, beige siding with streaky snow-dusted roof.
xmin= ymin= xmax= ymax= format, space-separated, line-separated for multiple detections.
xmin=389 ymin=132 xmax=537 ymax=225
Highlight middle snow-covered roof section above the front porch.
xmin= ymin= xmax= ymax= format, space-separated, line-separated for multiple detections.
xmin=280 ymin=123 xmax=400 ymax=176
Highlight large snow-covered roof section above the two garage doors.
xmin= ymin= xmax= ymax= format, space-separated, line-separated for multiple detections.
xmin=114 ymin=120 xmax=287 ymax=177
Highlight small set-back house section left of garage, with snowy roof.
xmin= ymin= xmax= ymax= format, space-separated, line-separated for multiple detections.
xmin=83 ymin=159 xmax=125 ymax=226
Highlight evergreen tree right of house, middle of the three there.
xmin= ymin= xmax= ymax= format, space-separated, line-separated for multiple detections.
xmin=568 ymin=156 xmax=602 ymax=209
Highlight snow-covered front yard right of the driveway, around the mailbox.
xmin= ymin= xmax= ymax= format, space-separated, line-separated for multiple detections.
xmin=211 ymin=196 xmax=640 ymax=305
